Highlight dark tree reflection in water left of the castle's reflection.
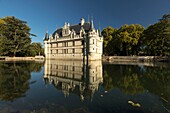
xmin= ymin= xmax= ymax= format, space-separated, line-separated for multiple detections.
xmin=0 ymin=62 xmax=43 ymax=101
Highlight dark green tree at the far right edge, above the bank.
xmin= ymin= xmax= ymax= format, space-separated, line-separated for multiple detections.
xmin=141 ymin=14 xmax=170 ymax=56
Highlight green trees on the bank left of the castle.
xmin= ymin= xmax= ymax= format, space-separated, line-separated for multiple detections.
xmin=0 ymin=16 xmax=43 ymax=56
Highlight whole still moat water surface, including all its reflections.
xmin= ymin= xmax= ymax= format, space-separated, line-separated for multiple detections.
xmin=0 ymin=61 xmax=170 ymax=113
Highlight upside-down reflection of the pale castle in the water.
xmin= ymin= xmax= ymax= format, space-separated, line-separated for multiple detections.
xmin=44 ymin=60 xmax=103 ymax=100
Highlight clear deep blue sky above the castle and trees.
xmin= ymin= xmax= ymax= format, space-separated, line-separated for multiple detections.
xmin=0 ymin=0 xmax=170 ymax=44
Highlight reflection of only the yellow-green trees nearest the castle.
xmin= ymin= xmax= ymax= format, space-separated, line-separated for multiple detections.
xmin=103 ymin=65 xmax=144 ymax=94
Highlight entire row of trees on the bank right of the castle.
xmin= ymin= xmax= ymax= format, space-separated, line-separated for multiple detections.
xmin=102 ymin=14 xmax=170 ymax=56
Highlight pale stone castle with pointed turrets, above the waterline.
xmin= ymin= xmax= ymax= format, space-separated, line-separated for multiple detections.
xmin=44 ymin=19 xmax=103 ymax=60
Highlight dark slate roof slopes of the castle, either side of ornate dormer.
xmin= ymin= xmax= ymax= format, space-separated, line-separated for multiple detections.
xmin=53 ymin=22 xmax=91 ymax=37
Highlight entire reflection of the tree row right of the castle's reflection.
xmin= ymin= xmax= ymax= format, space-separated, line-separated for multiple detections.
xmin=103 ymin=63 xmax=170 ymax=107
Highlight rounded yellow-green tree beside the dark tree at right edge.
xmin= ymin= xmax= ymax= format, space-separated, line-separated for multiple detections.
xmin=114 ymin=24 xmax=144 ymax=55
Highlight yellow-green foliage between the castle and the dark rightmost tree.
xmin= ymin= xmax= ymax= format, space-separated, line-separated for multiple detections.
xmin=102 ymin=24 xmax=144 ymax=55
